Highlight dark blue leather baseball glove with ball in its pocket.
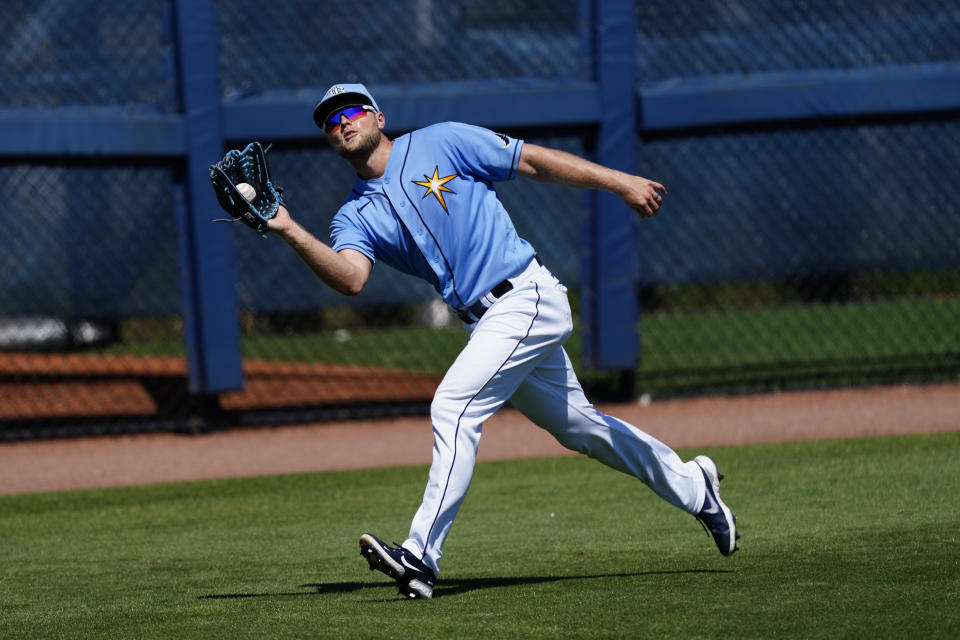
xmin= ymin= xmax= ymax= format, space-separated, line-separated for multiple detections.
xmin=210 ymin=142 xmax=283 ymax=236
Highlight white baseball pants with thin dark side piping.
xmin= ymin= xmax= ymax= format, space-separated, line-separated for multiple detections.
xmin=403 ymin=267 xmax=705 ymax=571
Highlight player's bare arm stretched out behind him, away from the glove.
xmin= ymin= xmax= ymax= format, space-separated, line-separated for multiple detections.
xmin=517 ymin=143 xmax=667 ymax=218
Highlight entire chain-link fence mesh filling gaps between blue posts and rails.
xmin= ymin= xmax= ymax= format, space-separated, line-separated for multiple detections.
xmin=0 ymin=0 xmax=960 ymax=437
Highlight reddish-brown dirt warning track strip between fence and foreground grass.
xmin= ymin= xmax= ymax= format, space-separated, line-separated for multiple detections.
xmin=0 ymin=384 xmax=960 ymax=493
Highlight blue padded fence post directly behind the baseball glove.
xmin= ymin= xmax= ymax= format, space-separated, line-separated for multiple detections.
xmin=173 ymin=0 xmax=243 ymax=395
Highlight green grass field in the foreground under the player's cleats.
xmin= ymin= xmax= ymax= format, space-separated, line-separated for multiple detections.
xmin=0 ymin=432 xmax=960 ymax=639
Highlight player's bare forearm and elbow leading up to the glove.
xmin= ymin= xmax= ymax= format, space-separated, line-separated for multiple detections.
xmin=269 ymin=205 xmax=373 ymax=296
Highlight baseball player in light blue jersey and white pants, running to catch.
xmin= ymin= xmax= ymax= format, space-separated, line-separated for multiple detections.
xmin=269 ymin=84 xmax=739 ymax=598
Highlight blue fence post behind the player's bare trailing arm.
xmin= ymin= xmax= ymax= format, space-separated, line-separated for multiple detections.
xmin=582 ymin=0 xmax=639 ymax=376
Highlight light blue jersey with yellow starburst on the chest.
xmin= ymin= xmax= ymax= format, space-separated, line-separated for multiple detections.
xmin=330 ymin=122 xmax=535 ymax=308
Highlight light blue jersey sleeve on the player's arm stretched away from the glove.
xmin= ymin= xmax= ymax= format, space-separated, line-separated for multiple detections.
xmin=447 ymin=122 xmax=523 ymax=182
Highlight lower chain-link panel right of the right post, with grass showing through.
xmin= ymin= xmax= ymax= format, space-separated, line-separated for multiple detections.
xmin=639 ymin=119 xmax=960 ymax=393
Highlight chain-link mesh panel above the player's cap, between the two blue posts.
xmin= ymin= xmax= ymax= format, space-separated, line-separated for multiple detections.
xmin=215 ymin=0 xmax=589 ymax=98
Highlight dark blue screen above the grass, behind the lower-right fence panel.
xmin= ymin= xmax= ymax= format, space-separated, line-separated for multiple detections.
xmin=639 ymin=119 xmax=960 ymax=285
